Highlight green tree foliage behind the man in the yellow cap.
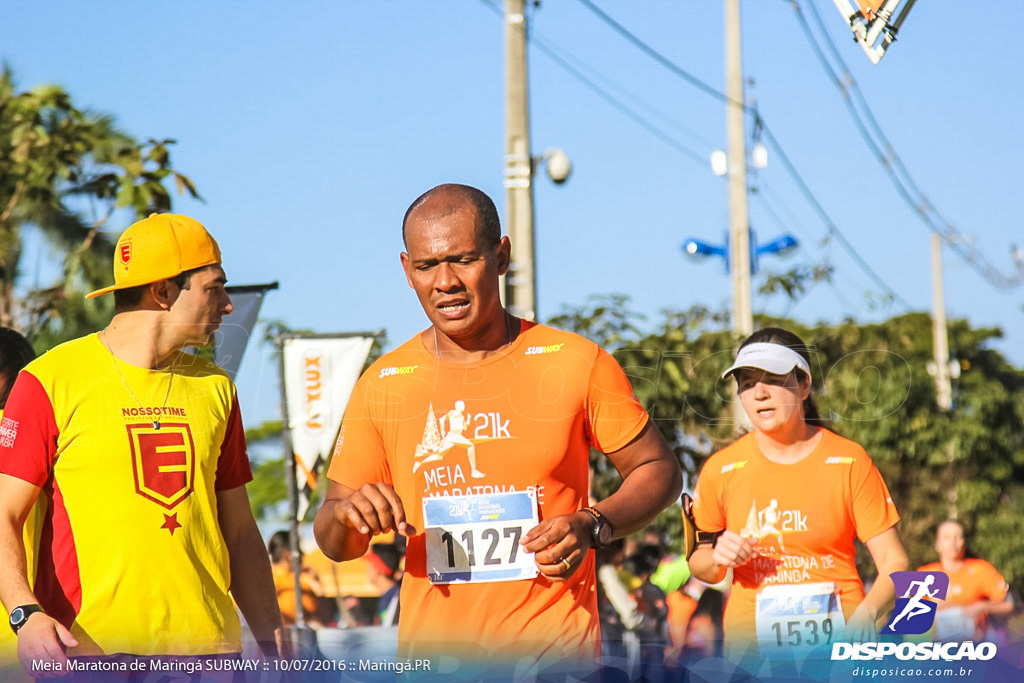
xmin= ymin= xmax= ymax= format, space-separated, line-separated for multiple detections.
xmin=0 ymin=68 xmax=199 ymax=348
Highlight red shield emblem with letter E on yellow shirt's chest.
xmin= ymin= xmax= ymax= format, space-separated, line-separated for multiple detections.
xmin=127 ymin=422 xmax=196 ymax=510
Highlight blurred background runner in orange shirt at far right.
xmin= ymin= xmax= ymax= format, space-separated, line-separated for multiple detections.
xmin=918 ymin=519 xmax=1014 ymax=640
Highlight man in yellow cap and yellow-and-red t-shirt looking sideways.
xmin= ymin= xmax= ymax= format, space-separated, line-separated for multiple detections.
xmin=0 ymin=214 xmax=281 ymax=675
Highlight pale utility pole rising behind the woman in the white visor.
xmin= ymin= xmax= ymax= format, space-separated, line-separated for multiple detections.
xmin=725 ymin=0 xmax=754 ymax=431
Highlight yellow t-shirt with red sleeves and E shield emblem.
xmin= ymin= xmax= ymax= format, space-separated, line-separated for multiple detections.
xmin=0 ymin=335 xmax=252 ymax=655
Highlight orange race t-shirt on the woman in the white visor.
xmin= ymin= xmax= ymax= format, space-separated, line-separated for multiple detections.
xmin=693 ymin=429 xmax=899 ymax=640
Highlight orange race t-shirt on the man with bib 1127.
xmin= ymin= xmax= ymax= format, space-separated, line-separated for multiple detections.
xmin=328 ymin=322 xmax=648 ymax=660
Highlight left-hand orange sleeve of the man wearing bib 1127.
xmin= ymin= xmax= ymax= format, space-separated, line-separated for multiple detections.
xmin=327 ymin=369 xmax=393 ymax=488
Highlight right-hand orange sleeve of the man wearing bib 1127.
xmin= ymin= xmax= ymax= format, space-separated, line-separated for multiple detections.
xmin=587 ymin=348 xmax=648 ymax=453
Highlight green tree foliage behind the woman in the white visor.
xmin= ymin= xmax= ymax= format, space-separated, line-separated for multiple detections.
xmin=551 ymin=297 xmax=1024 ymax=588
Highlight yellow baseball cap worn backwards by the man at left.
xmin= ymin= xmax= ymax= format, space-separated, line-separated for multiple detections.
xmin=85 ymin=213 xmax=220 ymax=299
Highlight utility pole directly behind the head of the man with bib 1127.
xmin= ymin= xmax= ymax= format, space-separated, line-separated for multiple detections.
xmin=502 ymin=0 xmax=537 ymax=321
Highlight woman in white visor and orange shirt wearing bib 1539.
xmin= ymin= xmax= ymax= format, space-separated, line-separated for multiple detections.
xmin=690 ymin=328 xmax=907 ymax=657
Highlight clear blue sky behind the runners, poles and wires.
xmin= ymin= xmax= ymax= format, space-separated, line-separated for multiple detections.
xmin=0 ymin=0 xmax=1024 ymax=424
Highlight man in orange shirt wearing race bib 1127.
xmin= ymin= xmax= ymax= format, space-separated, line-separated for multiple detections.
xmin=314 ymin=185 xmax=682 ymax=673
